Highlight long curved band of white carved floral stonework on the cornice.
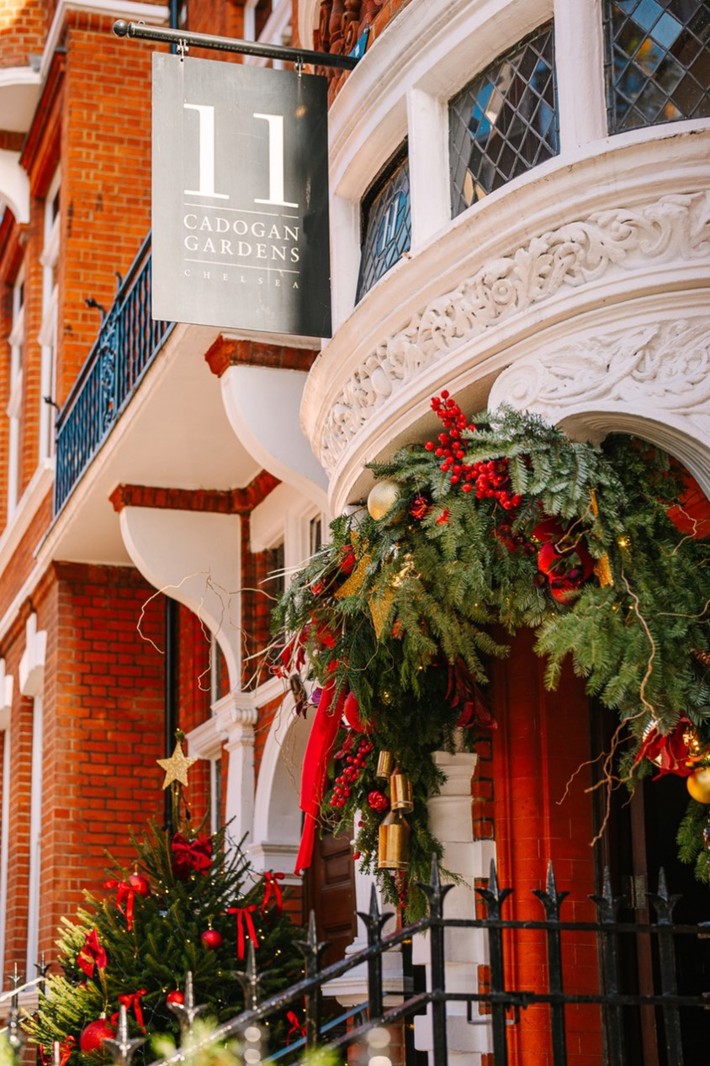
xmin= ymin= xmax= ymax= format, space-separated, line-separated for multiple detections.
xmin=314 ymin=192 xmax=710 ymax=473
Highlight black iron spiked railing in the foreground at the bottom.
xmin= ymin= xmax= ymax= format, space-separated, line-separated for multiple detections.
xmin=4 ymin=863 xmax=710 ymax=1066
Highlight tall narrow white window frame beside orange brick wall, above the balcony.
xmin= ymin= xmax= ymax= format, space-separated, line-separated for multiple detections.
xmin=38 ymin=169 xmax=62 ymax=462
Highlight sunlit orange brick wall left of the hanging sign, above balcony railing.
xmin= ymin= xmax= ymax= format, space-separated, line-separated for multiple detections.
xmin=58 ymin=13 xmax=151 ymax=403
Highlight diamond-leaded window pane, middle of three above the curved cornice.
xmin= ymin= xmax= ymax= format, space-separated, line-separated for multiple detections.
xmin=449 ymin=22 xmax=560 ymax=215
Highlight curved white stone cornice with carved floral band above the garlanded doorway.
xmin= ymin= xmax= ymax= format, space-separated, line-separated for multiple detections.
xmin=302 ymin=150 xmax=710 ymax=511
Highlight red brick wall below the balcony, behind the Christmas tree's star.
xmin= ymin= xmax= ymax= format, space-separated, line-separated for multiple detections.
xmin=38 ymin=564 xmax=164 ymax=950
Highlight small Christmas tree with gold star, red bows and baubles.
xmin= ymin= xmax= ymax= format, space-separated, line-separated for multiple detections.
xmin=26 ymin=743 xmax=303 ymax=1066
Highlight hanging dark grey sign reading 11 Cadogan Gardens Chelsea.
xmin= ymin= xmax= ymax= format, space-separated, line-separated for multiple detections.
xmin=152 ymin=52 xmax=330 ymax=337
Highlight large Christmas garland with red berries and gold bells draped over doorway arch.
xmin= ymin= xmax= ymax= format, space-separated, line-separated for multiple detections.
xmin=275 ymin=392 xmax=710 ymax=915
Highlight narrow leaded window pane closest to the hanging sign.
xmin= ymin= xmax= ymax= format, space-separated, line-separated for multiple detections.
xmin=356 ymin=149 xmax=412 ymax=302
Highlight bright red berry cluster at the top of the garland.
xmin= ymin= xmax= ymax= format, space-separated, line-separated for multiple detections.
xmin=424 ymin=389 xmax=520 ymax=511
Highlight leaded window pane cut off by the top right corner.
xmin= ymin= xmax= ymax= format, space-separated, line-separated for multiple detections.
xmin=604 ymin=0 xmax=710 ymax=133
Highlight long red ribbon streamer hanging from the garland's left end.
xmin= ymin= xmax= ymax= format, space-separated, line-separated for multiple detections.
xmin=295 ymin=663 xmax=348 ymax=873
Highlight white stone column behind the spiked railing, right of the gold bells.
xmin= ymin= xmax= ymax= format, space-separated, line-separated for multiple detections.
xmin=414 ymin=752 xmax=494 ymax=1066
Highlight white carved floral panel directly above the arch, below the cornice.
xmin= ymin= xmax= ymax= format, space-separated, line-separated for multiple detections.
xmin=489 ymin=318 xmax=710 ymax=431
